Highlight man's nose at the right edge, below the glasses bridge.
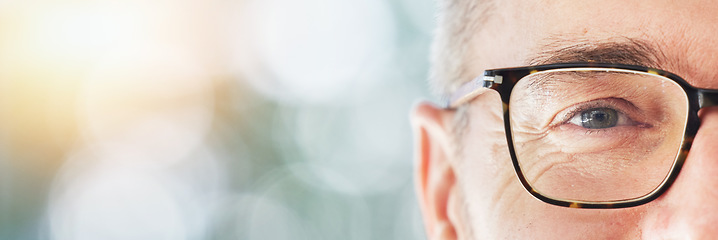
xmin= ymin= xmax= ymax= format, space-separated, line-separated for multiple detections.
xmin=642 ymin=107 xmax=718 ymax=239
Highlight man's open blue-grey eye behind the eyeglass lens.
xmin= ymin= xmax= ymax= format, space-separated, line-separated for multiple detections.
xmin=568 ymin=107 xmax=633 ymax=129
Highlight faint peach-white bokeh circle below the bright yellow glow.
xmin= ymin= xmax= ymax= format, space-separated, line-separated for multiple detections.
xmin=80 ymin=46 xmax=214 ymax=169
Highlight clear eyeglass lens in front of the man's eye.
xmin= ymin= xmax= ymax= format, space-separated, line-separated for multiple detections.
xmin=509 ymin=69 xmax=688 ymax=202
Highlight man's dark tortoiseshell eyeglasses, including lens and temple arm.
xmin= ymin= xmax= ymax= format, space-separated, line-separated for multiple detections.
xmin=447 ymin=63 xmax=718 ymax=208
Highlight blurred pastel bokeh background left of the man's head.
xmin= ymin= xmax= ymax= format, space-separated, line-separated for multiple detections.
xmin=0 ymin=0 xmax=435 ymax=240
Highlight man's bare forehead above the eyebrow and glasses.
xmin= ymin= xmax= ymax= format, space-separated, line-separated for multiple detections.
xmin=475 ymin=0 xmax=718 ymax=88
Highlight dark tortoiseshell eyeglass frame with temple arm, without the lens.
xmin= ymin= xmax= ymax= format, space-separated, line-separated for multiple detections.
xmin=446 ymin=62 xmax=718 ymax=209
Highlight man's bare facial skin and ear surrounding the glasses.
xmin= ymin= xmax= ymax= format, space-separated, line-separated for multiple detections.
xmin=412 ymin=0 xmax=718 ymax=239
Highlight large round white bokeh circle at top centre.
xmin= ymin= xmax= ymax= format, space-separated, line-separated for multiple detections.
xmin=235 ymin=0 xmax=396 ymax=103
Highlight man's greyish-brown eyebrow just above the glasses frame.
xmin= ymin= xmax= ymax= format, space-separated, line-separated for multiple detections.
xmin=527 ymin=37 xmax=667 ymax=68
